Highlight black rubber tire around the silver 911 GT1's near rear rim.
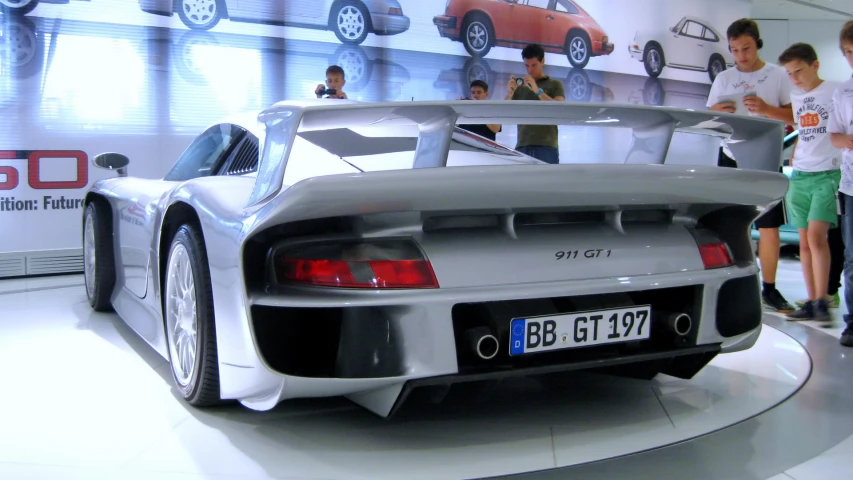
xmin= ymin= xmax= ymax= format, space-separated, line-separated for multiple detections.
xmin=162 ymin=224 xmax=223 ymax=407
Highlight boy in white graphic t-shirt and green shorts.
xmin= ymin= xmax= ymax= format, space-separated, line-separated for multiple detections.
xmin=779 ymin=43 xmax=841 ymax=321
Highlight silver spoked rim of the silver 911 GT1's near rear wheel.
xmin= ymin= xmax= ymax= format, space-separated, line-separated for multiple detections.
xmin=166 ymin=244 xmax=198 ymax=387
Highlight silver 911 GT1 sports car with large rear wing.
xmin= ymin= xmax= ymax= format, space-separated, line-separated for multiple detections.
xmin=83 ymin=100 xmax=788 ymax=417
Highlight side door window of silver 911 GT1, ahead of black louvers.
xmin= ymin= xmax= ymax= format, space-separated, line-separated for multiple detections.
xmin=164 ymin=123 xmax=238 ymax=182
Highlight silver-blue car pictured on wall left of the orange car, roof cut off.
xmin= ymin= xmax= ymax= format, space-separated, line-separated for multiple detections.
xmin=139 ymin=0 xmax=411 ymax=45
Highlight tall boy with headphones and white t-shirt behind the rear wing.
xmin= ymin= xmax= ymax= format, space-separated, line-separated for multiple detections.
xmin=707 ymin=18 xmax=794 ymax=313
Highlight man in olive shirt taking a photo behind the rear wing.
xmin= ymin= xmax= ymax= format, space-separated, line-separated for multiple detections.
xmin=506 ymin=44 xmax=566 ymax=164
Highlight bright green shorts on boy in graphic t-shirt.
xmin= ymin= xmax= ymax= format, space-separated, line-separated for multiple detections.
xmin=785 ymin=170 xmax=841 ymax=228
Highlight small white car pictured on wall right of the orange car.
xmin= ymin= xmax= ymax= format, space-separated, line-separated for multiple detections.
xmin=628 ymin=17 xmax=734 ymax=82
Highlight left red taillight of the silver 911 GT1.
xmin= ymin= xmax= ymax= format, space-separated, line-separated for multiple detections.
xmin=273 ymin=241 xmax=438 ymax=289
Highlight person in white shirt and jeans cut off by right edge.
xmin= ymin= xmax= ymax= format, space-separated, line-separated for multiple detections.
xmin=829 ymin=20 xmax=853 ymax=347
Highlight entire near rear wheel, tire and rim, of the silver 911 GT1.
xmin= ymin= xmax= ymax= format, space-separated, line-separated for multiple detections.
xmin=163 ymin=224 xmax=221 ymax=407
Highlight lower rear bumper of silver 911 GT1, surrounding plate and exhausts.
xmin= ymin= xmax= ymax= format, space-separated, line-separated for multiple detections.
xmin=230 ymin=267 xmax=761 ymax=417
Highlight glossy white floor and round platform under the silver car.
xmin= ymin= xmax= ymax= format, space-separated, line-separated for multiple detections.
xmin=0 ymin=276 xmax=824 ymax=480
